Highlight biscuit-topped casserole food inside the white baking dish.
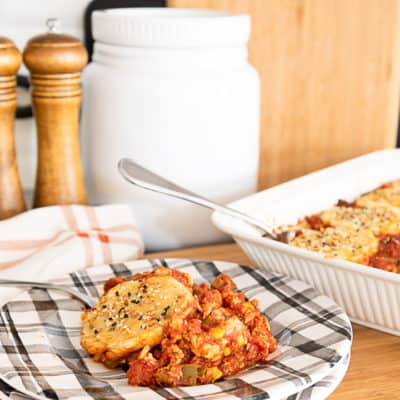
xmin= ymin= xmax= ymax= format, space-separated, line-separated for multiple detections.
xmin=277 ymin=180 xmax=400 ymax=273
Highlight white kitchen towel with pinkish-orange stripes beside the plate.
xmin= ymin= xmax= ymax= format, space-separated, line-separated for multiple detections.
xmin=0 ymin=204 xmax=143 ymax=304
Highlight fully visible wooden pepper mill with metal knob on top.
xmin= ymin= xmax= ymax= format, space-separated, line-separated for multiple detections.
xmin=24 ymin=19 xmax=88 ymax=207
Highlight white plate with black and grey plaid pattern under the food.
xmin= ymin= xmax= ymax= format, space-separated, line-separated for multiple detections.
xmin=0 ymin=259 xmax=352 ymax=400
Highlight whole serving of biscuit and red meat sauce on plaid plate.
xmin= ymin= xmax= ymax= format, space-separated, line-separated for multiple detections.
xmin=81 ymin=267 xmax=276 ymax=386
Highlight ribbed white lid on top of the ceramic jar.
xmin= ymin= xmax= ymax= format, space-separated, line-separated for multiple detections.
xmin=92 ymin=8 xmax=250 ymax=48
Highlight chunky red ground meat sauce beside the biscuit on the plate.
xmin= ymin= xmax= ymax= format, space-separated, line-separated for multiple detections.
xmin=94 ymin=268 xmax=277 ymax=386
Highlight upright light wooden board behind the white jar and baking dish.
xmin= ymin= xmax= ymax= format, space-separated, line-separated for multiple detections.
xmin=169 ymin=0 xmax=400 ymax=189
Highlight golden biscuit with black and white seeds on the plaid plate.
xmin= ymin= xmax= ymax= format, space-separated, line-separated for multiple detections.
xmin=81 ymin=274 xmax=196 ymax=361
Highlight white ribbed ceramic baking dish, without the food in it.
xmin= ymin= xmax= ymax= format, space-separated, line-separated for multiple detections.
xmin=212 ymin=149 xmax=400 ymax=335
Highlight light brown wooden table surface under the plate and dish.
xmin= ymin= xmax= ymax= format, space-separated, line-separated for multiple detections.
xmin=147 ymin=244 xmax=400 ymax=400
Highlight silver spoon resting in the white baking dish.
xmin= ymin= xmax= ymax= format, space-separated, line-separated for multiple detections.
xmin=118 ymin=158 xmax=296 ymax=243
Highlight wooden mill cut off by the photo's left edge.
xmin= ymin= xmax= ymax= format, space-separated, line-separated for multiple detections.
xmin=0 ymin=37 xmax=25 ymax=219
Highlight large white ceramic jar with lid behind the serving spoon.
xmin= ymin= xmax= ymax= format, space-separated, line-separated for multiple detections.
xmin=81 ymin=8 xmax=259 ymax=250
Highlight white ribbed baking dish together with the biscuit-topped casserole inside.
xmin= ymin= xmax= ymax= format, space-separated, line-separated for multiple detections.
xmin=212 ymin=149 xmax=400 ymax=335
